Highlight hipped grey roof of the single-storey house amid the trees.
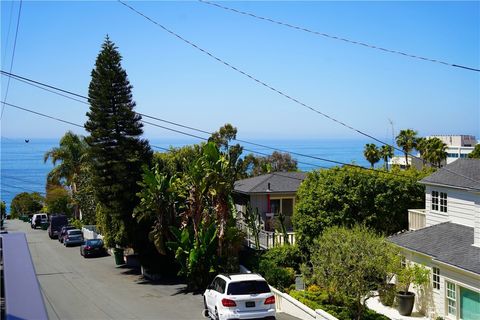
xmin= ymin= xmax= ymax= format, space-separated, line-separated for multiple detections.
xmin=234 ymin=172 xmax=307 ymax=194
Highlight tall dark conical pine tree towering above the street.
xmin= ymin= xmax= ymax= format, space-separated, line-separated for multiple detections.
xmin=85 ymin=36 xmax=152 ymax=248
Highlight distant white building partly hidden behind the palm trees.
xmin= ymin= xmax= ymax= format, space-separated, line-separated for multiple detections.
xmin=388 ymin=135 xmax=477 ymax=169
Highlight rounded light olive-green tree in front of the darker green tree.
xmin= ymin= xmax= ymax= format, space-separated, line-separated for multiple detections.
xmin=311 ymin=226 xmax=399 ymax=319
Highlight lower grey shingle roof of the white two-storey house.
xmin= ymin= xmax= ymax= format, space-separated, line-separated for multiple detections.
xmin=389 ymin=222 xmax=480 ymax=274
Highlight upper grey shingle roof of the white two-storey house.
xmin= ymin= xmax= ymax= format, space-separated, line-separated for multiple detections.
xmin=420 ymin=158 xmax=480 ymax=191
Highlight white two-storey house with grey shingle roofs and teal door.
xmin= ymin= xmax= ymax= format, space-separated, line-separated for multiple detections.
xmin=389 ymin=158 xmax=480 ymax=320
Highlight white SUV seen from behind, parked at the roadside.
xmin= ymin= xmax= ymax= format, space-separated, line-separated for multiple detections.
xmin=203 ymin=273 xmax=275 ymax=320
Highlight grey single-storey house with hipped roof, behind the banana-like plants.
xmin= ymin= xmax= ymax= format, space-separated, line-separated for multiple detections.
xmin=234 ymin=172 xmax=306 ymax=231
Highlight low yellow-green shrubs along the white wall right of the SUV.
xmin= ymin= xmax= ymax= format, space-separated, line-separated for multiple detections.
xmin=289 ymin=287 xmax=389 ymax=320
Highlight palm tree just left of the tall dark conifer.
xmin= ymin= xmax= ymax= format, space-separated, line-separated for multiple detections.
xmin=43 ymin=131 xmax=88 ymax=218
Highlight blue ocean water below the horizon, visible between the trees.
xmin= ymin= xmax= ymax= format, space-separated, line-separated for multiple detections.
xmin=0 ymin=137 xmax=369 ymax=211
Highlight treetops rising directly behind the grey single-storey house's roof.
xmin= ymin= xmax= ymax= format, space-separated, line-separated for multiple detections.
xmin=242 ymin=151 xmax=298 ymax=178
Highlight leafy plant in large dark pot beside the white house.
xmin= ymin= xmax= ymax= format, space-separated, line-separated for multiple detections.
xmin=396 ymin=263 xmax=430 ymax=316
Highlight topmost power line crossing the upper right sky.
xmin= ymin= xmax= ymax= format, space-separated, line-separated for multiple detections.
xmin=198 ymin=0 xmax=480 ymax=72
